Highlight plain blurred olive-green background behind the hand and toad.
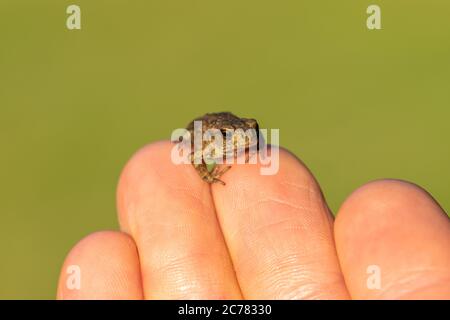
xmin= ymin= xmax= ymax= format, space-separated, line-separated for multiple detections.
xmin=0 ymin=0 xmax=450 ymax=299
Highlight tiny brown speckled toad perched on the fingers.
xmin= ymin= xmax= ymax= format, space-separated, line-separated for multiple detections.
xmin=186 ymin=112 xmax=259 ymax=185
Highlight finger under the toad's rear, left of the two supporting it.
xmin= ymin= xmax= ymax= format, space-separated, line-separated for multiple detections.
xmin=117 ymin=141 xmax=241 ymax=299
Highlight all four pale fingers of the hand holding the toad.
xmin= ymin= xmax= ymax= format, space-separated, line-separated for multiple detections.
xmin=57 ymin=142 xmax=450 ymax=299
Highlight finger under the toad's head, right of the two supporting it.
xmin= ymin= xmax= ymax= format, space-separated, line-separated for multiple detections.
xmin=212 ymin=150 xmax=348 ymax=299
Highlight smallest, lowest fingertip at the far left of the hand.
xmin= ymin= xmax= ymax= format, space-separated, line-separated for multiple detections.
xmin=57 ymin=231 xmax=143 ymax=300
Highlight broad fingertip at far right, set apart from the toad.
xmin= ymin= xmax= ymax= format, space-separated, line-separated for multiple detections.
xmin=334 ymin=180 xmax=450 ymax=299
